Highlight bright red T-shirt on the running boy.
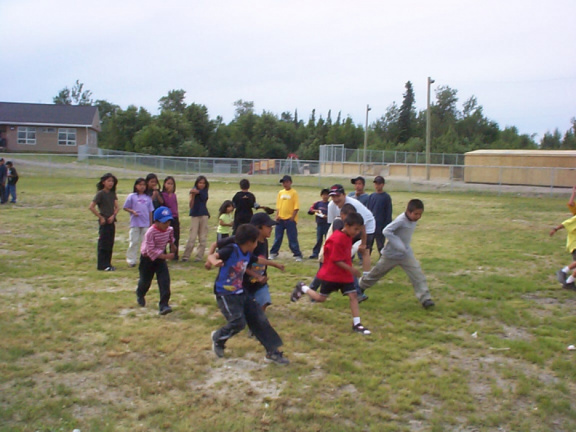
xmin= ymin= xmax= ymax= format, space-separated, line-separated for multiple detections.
xmin=318 ymin=231 xmax=354 ymax=283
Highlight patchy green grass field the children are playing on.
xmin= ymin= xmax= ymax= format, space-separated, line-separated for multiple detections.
xmin=0 ymin=174 xmax=576 ymax=432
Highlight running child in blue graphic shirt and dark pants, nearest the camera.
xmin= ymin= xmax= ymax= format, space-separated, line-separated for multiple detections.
xmin=207 ymin=224 xmax=289 ymax=365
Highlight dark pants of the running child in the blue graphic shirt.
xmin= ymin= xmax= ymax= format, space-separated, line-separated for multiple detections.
xmin=214 ymin=293 xmax=282 ymax=352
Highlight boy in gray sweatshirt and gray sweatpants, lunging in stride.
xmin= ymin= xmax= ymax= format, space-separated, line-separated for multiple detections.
xmin=359 ymin=199 xmax=434 ymax=309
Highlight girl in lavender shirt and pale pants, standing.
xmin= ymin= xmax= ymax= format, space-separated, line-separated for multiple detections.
xmin=123 ymin=177 xmax=154 ymax=267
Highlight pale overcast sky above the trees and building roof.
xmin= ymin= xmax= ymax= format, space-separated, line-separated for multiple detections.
xmin=0 ymin=0 xmax=576 ymax=137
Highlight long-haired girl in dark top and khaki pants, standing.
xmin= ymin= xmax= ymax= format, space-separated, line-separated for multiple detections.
xmin=182 ymin=176 xmax=210 ymax=261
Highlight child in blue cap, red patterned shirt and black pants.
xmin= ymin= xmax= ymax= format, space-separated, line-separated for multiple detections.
xmin=136 ymin=206 xmax=176 ymax=315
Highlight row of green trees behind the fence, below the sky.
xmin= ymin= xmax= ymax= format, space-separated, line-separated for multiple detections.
xmin=54 ymin=81 xmax=576 ymax=159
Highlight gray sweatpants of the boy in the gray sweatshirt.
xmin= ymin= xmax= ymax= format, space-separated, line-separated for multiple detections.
xmin=360 ymin=255 xmax=430 ymax=303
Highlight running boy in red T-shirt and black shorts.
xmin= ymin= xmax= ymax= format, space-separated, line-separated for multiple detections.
xmin=290 ymin=213 xmax=370 ymax=335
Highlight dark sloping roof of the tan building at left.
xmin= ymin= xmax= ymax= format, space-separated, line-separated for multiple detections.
xmin=0 ymin=102 xmax=100 ymax=130
